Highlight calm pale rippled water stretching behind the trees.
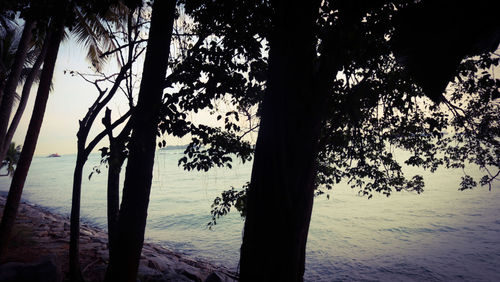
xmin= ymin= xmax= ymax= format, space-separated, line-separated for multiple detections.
xmin=0 ymin=150 xmax=500 ymax=281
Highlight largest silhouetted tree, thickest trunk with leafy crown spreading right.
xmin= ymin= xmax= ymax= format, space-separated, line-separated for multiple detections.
xmin=198 ymin=1 xmax=498 ymax=281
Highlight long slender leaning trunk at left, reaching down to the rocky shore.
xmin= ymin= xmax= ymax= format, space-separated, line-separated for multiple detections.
xmin=0 ymin=10 xmax=66 ymax=256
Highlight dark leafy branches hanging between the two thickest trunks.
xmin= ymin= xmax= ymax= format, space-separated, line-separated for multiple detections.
xmin=159 ymin=1 xmax=270 ymax=171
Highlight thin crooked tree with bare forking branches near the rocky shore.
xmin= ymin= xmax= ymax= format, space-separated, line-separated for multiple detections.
xmin=66 ymin=10 xmax=145 ymax=275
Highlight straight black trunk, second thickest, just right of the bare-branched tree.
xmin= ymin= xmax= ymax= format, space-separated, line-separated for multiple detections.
xmin=107 ymin=0 xmax=176 ymax=282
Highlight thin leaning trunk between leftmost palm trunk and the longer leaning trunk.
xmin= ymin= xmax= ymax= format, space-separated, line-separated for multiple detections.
xmin=0 ymin=31 xmax=50 ymax=160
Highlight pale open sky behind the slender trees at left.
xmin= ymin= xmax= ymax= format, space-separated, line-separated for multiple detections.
xmin=13 ymin=39 xmax=189 ymax=155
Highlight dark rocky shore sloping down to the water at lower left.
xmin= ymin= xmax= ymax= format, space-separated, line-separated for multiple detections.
xmin=0 ymin=196 xmax=236 ymax=281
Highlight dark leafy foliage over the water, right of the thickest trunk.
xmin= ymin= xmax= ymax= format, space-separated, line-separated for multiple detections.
xmin=205 ymin=1 xmax=500 ymax=224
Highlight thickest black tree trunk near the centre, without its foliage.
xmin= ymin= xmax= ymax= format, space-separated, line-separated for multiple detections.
xmin=240 ymin=1 xmax=323 ymax=281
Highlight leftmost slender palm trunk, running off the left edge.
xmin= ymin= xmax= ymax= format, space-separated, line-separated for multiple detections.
xmin=0 ymin=19 xmax=35 ymax=162
